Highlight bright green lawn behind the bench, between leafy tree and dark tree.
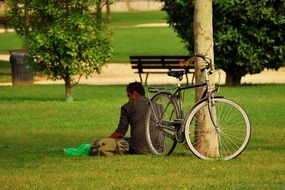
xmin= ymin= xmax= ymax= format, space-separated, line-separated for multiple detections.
xmin=112 ymin=27 xmax=189 ymax=62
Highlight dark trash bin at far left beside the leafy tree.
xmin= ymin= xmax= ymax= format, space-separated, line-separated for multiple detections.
xmin=10 ymin=51 xmax=34 ymax=86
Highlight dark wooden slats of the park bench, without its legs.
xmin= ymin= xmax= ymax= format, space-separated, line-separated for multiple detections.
xmin=130 ymin=55 xmax=194 ymax=73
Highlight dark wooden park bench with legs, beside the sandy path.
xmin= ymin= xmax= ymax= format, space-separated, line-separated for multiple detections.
xmin=130 ymin=55 xmax=195 ymax=85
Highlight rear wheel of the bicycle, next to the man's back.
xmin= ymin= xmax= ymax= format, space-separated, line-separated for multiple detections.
xmin=145 ymin=92 xmax=180 ymax=155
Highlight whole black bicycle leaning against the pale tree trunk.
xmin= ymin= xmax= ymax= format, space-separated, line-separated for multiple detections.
xmin=145 ymin=54 xmax=251 ymax=160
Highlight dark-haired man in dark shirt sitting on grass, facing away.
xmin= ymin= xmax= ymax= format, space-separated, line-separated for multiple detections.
xmin=110 ymin=82 xmax=150 ymax=154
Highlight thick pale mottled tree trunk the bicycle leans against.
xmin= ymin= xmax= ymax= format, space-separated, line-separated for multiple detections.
xmin=193 ymin=0 xmax=219 ymax=157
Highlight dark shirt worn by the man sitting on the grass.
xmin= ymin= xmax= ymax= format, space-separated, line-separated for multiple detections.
xmin=116 ymin=96 xmax=150 ymax=154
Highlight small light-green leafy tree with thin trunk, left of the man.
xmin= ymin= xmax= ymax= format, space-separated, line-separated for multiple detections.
xmin=8 ymin=0 xmax=112 ymax=100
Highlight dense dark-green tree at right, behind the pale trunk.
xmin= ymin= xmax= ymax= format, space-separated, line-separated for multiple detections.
xmin=162 ymin=0 xmax=285 ymax=85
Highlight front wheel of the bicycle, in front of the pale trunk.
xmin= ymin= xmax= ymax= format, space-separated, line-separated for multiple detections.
xmin=184 ymin=98 xmax=251 ymax=160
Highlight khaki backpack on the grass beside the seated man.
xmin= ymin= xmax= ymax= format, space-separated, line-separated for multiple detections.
xmin=90 ymin=138 xmax=129 ymax=156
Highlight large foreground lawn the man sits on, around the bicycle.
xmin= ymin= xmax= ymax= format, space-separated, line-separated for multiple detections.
xmin=0 ymin=85 xmax=285 ymax=189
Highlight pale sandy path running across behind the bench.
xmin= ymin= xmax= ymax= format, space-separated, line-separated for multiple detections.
xmin=0 ymin=55 xmax=285 ymax=85
